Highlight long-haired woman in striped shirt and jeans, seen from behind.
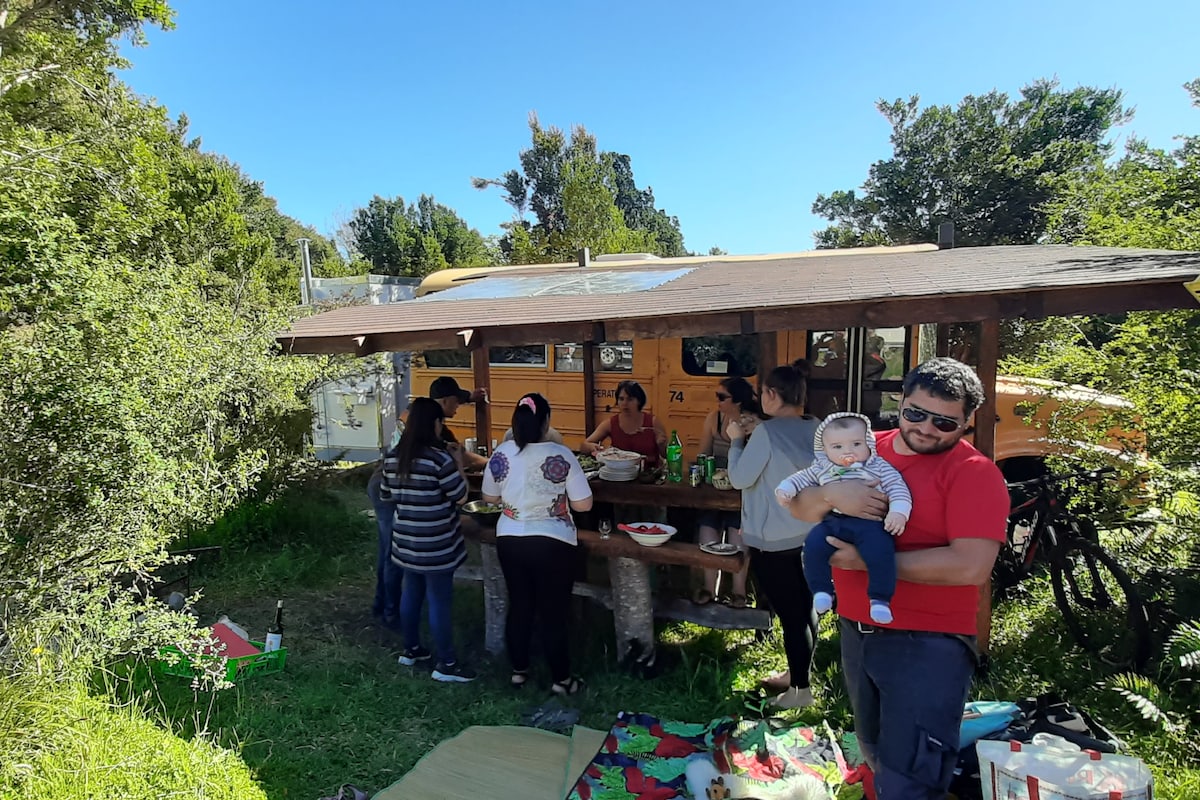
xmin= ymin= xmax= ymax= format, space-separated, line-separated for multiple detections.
xmin=380 ymin=397 xmax=475 ymax=684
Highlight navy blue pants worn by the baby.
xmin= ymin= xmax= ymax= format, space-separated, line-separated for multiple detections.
xmin=804 ymin=513 xmax=896 ymax=602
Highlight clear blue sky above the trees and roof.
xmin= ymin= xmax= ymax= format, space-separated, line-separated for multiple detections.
xmin=122 ymin=0 xmax=1200 ymax=253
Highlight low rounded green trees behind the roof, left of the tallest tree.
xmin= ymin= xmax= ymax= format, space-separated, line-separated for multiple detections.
xmin=347 ymin=194 xmax=490 ymax=277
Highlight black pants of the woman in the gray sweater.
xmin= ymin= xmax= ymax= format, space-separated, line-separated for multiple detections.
xmin=750 ymin=548 xmax=817 ymax=688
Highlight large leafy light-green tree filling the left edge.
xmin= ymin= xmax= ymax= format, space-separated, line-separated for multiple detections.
xmin=0 ymin=0 xmax=338 ymax=674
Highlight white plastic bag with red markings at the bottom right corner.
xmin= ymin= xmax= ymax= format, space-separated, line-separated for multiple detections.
xmin=976 ymin=733 xmax=1154 ymax=800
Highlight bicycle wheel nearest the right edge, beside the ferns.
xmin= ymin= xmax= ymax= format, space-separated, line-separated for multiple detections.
xmin=1050 ymin=537 xmax=1151 ymax=669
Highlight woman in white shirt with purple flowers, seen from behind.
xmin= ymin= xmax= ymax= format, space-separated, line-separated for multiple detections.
xmin=482 ymin=392 xmax=592 ymax=694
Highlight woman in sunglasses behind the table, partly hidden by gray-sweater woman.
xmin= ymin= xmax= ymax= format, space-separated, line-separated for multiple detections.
xmin=692 ymin=378 xmax=762 ymax=608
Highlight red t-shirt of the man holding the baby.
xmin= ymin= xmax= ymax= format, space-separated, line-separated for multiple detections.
xmin=833 ymin=431 xmax=1008 ymax=636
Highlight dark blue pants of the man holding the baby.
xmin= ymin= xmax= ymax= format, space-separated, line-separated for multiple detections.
xmin=840 ymin=619 xmax=976 ymax=800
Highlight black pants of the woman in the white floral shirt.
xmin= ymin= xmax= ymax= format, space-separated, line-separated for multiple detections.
xmin=496 ymin=536 xmax=576 ymax=682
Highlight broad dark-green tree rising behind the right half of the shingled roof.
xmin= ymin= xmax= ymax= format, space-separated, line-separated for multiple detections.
xmin=812 ymin=80 xmax=1128 ymax=247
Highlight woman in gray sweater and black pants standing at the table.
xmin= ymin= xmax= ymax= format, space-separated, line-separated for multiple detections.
xmin=726 ymin=359 xmax=820 ymax=709
